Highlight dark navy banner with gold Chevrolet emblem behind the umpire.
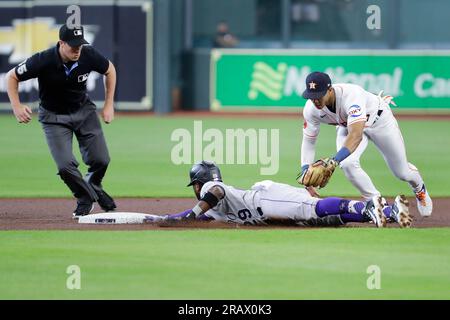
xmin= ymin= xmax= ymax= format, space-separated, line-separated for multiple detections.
xmin=0 ymin=0 xmax=152 ymax=110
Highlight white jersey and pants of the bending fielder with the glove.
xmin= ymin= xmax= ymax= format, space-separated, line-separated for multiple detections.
xmin=301 ymin=83 xmax=423 ymax=200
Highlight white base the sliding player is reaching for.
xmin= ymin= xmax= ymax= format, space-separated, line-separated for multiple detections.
xmin=78 ymin=212 xmax=159 ymax=224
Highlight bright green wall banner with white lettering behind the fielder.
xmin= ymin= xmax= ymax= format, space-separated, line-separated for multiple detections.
xmin=210 ymin=49 xmax=450 ymax=110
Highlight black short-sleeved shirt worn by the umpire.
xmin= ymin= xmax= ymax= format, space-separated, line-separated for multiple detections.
xmin=15 ymin=44 xmax=109 ymax=113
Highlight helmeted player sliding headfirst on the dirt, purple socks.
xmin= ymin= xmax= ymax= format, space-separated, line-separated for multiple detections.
xmin=146 ymin=161 xmax=412 ymax=228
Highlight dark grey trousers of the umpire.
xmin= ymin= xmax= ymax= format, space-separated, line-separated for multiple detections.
xmin=39 ymin=102 xmax=110 ymax=203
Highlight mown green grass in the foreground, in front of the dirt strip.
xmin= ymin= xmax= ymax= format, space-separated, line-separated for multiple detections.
xmin=0 ymin=228 xmax=450 ymax=299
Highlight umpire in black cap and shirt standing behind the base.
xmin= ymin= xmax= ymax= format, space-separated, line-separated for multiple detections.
xmin=6 ymin=25 xmax=116 ymax=218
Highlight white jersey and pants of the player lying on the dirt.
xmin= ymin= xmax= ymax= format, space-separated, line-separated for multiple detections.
xmin=200 ymin=180 xmax=319 ymax=225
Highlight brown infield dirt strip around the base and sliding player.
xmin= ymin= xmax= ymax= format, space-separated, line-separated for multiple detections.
xmin=0 ymin=198 xmax=450 ymax=230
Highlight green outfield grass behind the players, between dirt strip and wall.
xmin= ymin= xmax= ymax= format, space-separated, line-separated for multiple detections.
xmin=0 ymin=115 xmax=450 ymax=198
